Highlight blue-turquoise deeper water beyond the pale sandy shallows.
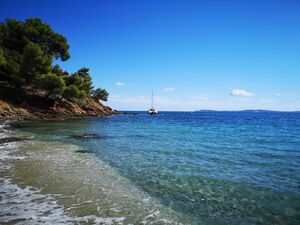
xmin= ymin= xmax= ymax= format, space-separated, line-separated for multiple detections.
xmin=8 ymin=111 xmax=300 ymax=225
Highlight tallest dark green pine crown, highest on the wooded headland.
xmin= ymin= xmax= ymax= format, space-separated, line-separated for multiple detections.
xmin=0 ymin=18 xmax=70 ymax=82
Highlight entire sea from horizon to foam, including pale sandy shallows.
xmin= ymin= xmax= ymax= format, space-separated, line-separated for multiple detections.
xmin=0 ymin=110 xmax=300 ymax=225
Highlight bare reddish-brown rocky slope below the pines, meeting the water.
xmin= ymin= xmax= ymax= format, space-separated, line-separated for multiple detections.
xmin=0 ymin=82 xmax=117 ymax=120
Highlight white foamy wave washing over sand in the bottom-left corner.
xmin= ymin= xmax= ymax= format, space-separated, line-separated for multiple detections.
xmin=0 ymin=178 xmax=125 ymax=224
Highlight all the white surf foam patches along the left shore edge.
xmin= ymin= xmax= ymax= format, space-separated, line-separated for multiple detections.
xmin=0 ymin=123 xmax=125 ymax=224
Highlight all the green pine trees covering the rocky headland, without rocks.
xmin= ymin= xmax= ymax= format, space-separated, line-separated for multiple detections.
xmin=0 ymin=18 xmax=109 ymax=102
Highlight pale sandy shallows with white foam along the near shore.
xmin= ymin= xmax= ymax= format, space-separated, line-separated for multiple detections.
xmin=0 ymin=120 xmax=188 ymax=224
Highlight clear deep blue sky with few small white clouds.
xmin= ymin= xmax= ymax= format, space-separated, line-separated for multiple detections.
xmin=0 ymin=0 xmax=300 ymax=111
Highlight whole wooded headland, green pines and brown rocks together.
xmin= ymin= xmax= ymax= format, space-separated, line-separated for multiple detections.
xmin=0 ymin=18 xmax=116 ymax=120
